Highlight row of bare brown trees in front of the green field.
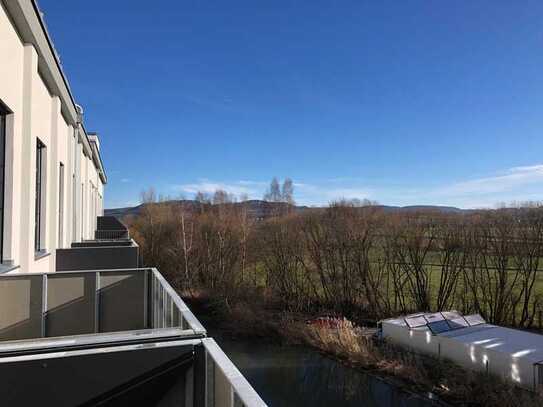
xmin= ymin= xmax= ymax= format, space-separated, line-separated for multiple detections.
xmin=128 ymin=189 xmax=543 ymax=327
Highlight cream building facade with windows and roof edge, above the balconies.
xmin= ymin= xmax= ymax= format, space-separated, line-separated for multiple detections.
xmin=0 ymin=0 xmax=106 ymax=272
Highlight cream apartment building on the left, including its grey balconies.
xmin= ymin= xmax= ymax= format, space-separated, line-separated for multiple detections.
xmin=0 ymin=0 xmax=266 ymax=407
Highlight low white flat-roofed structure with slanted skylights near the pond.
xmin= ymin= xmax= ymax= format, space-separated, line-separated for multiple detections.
xmin=380 ymin=311 xmax=543 ymax=390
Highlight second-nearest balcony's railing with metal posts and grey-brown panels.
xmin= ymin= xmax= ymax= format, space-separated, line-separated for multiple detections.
xmin=0 ymin=269 xmax=205 ymax=340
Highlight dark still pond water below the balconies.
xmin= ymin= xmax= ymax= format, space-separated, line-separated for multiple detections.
xmin=208 ymin=331 xmax=438 ymax=407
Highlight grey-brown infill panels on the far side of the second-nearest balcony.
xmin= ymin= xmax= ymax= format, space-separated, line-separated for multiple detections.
xmin=0 ymin=271 xmax=149 ymax=341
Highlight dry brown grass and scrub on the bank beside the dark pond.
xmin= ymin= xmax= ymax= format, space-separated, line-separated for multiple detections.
xmin=291 ymin=321 xmax=541 ymax=407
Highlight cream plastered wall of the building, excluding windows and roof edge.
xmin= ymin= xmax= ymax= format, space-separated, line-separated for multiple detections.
xmin=0 ymin=0 xmax=103 ymax=272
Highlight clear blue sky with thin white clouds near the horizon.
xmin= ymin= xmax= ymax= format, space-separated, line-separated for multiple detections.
xmin=40 ymin=0 xmax=543 ymax=208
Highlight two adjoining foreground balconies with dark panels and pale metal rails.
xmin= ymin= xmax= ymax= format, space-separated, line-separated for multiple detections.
xmin=0 ymin=268 xmax=265 ymax=407
